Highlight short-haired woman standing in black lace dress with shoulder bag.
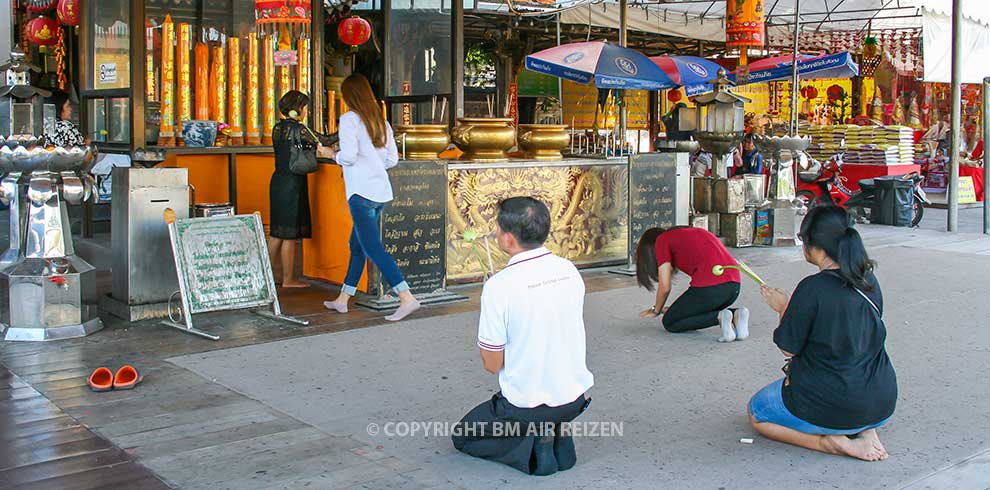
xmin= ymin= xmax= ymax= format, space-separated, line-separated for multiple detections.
xmin=268 ymin=90 xmax=332 ymax=288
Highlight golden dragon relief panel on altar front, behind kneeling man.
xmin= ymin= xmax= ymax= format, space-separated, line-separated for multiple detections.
xmin=447 ymin=164 xmax=628 ymax=281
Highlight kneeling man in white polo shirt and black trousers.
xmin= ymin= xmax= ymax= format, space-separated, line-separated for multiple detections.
xmin=452 ymin=197 xmax=594 ymax=475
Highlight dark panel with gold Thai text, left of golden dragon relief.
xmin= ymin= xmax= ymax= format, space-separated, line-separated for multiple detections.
xmin=377 ymin=160 xmax=447 ymax=294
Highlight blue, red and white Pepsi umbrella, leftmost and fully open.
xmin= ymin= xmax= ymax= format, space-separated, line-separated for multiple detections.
xmin=526 ymin=41 xmax=680 ymax=90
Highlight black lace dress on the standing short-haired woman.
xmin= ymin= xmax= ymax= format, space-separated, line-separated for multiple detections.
xmin=268 ymin=119 xmax=332 ymax=240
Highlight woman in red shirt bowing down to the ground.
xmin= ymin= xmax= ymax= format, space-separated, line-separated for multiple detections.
xmin=636 ymin=226 xmax=749 ymax=342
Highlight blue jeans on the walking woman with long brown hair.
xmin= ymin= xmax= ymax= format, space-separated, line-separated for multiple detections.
xmin=342 ymin=194 xmax=409 ymax=296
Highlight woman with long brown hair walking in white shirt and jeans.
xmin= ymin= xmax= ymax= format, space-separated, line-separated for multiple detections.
xmin=323 ymin=74 xmax=419 ymax=321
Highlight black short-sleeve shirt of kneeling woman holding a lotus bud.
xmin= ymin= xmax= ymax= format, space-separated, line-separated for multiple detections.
xmin=773 ymin=271 xmax=897 ymax=429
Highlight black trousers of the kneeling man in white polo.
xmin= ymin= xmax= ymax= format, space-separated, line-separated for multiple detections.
xmin=451 ymin=392 xmax=591 ymax=476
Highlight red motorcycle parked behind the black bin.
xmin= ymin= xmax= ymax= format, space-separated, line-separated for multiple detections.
xmin=797 ymin=153 xmax=931 ymax=227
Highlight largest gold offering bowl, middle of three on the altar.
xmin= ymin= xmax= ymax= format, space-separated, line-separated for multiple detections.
xmin=450 ymin=117 xmax=516 ymax=162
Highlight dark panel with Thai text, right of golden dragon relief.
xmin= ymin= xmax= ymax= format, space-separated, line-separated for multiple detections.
xmin=629 ymin=153 xmax=685 ymax=257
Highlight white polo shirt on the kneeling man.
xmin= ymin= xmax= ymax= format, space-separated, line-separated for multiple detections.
xmin=478 ymin=247 xmax=595 ymax=408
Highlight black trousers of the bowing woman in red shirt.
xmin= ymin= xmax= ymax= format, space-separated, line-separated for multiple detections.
xmin=662 ymin=282 xmax=739 ymax=333
